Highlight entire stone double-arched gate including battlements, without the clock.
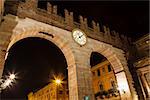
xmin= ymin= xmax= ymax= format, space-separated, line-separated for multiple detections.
xmin=0 ymin=0 xmax=137 ymax=100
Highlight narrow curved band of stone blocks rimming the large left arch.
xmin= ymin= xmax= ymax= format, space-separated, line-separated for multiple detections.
xmin=5 ymin=30 xmax=75 ymax=98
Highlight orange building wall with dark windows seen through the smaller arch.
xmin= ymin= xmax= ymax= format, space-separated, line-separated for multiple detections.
xmin=91 ymin=60 xmax=119 ymax=99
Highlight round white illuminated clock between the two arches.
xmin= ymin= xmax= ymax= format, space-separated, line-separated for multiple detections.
xmin=72 ymin=29 xmax=87 ymax=46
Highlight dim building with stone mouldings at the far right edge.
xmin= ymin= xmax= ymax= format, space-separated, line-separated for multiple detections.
xmin=134 ymin=34 xmax=150 ymax=99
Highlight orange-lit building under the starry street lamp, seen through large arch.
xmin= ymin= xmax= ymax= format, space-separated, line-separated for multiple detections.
xmin=28 ymin=83 xmax=69 ymax=100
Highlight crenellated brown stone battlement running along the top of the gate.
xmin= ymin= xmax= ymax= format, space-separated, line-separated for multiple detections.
xmin=17 ymin=0 xmax=131 ymax=50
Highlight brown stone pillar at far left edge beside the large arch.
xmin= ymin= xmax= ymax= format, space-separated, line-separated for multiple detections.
xmin=0 ymin=15 xmax=17 ymax=78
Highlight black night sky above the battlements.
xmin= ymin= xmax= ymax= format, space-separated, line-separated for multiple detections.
xmin=39 ymin=0 xmax=149 ymax=39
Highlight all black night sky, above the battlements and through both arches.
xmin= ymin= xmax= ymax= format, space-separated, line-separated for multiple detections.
xmin=2 ymin=0 xmax=149 ymax=100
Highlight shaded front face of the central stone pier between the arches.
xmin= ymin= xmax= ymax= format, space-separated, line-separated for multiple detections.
xmin=77 ymin=64 xmax=94 ymax=100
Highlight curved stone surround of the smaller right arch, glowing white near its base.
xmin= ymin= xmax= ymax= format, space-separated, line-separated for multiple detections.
xmin=88 ymin=38 xmax=137 ymax=100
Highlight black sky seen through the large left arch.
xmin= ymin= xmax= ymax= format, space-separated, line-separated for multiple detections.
xmin=2 ymin=37 xmax=68 ymax=99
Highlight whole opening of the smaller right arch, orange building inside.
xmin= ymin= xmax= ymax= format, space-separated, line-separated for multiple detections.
xmin=90 ymin=52 xmax=120 ymax=100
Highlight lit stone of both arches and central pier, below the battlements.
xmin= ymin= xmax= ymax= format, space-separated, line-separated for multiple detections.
xmin=0 ymin=16 xmax=137 ymax=100
